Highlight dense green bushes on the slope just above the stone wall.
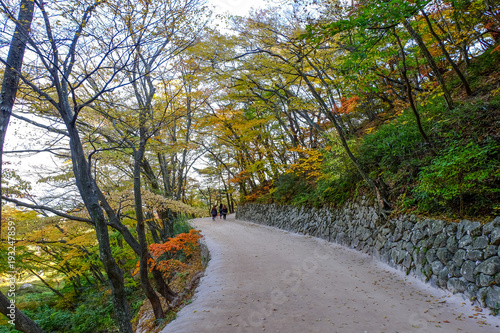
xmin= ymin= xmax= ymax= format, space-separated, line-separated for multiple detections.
xmin=247 ymin=44 xmax=500 ymax=220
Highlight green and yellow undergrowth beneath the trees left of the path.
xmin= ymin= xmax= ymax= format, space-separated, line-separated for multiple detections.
xmin=0 ymin=219 xmax=204 ymax=333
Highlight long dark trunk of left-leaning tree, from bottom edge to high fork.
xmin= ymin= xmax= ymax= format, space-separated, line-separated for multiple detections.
xmin=27 ymin=2 xmax=133 ymax=326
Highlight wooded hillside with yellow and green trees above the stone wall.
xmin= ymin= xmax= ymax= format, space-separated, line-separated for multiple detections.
xmin=211 ymin=1 xmax=500 ymax=219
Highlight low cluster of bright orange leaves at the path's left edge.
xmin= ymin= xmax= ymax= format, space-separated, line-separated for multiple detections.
xmin=142 ymin=229 xmax=203 ymax=275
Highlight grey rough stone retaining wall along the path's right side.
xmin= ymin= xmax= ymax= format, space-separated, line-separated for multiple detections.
xmin=236 ymin=200 xmax=500 ymax=313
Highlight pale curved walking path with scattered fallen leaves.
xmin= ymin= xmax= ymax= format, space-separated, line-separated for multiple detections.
xmin=162 ymin=215 xmax=500 ymax=333
